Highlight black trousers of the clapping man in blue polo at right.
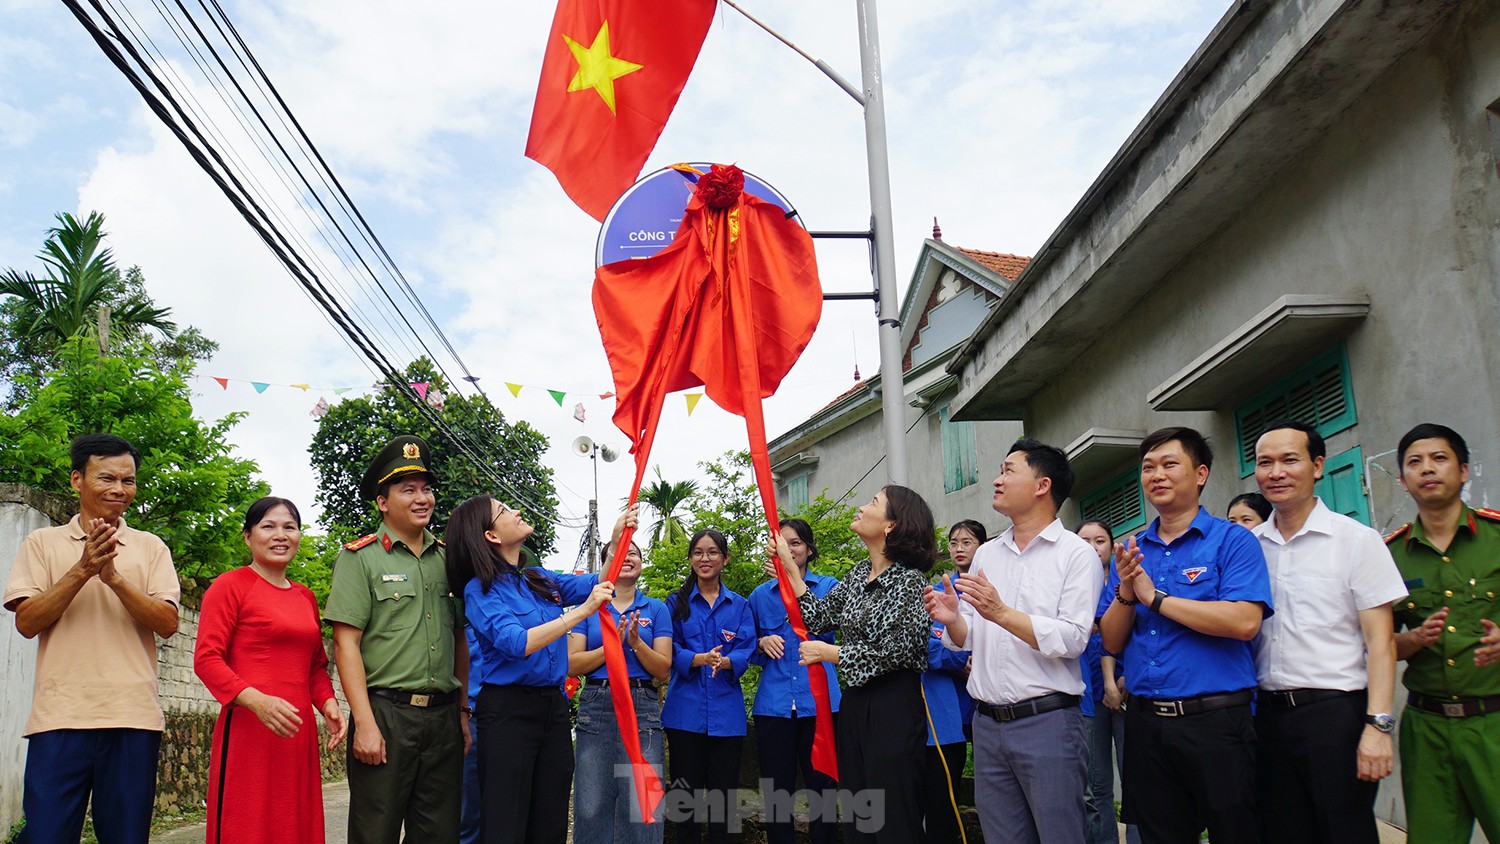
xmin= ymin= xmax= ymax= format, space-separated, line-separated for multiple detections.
xmin=1121 ymin=703 xmax=1260 ymax=844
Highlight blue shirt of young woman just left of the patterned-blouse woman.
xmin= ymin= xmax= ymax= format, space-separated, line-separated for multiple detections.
xmin=750 ymin=573 xmax=840 ymax=718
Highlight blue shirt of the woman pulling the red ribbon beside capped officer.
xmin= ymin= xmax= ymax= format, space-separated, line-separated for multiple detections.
xmin=464 ymin=571 xmax=599 ymax=690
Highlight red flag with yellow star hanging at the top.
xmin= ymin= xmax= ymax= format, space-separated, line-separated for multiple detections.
xmin=527 ymin=0 xmax=716 ymax=220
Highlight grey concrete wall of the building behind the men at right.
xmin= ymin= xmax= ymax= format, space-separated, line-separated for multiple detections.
xmin=1026 ymin=3 xmax=1500 ymax=841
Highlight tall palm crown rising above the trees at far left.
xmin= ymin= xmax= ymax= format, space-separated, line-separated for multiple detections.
xmin=0 ymin=211 xmax=177 ymax=353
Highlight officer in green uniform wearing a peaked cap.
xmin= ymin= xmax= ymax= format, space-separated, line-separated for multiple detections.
xmin=323 ymin=436 xmax=470 ymax=844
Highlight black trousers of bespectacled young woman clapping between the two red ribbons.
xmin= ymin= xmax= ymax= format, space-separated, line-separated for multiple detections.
xmin=666 ymin=730 xmax=744 ymax=844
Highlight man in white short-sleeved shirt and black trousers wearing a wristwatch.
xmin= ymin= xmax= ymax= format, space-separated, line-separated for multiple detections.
xmin=1254 ymin=421 xmax=1407 ymax=844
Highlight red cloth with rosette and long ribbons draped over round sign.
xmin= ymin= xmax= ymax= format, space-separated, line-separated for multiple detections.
xmin=594 ymin=165 xmax=839 ymax=780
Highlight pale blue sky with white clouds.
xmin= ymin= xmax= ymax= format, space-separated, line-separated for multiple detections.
xmin=0 ymin=0 xmax=1227 ymax=564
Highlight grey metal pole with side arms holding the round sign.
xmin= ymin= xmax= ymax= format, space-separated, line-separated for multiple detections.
xmin=723 ymin=0 xmax=908 ymax=486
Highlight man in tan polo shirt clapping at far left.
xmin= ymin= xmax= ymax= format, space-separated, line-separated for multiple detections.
xmin=5 ymin=433 xmax=180 ymax=844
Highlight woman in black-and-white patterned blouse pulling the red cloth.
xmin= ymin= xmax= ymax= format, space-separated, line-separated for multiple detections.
xmin=777 ymin=484 xmax=938 ymax=844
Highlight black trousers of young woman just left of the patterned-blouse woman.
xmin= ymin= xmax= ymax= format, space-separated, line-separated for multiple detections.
xmin=755 ymin=714 xmax=839 ymax=844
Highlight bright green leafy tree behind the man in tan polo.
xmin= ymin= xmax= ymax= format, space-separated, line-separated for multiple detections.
xmin=0 ymin=337 xmax=269 ymax=589
